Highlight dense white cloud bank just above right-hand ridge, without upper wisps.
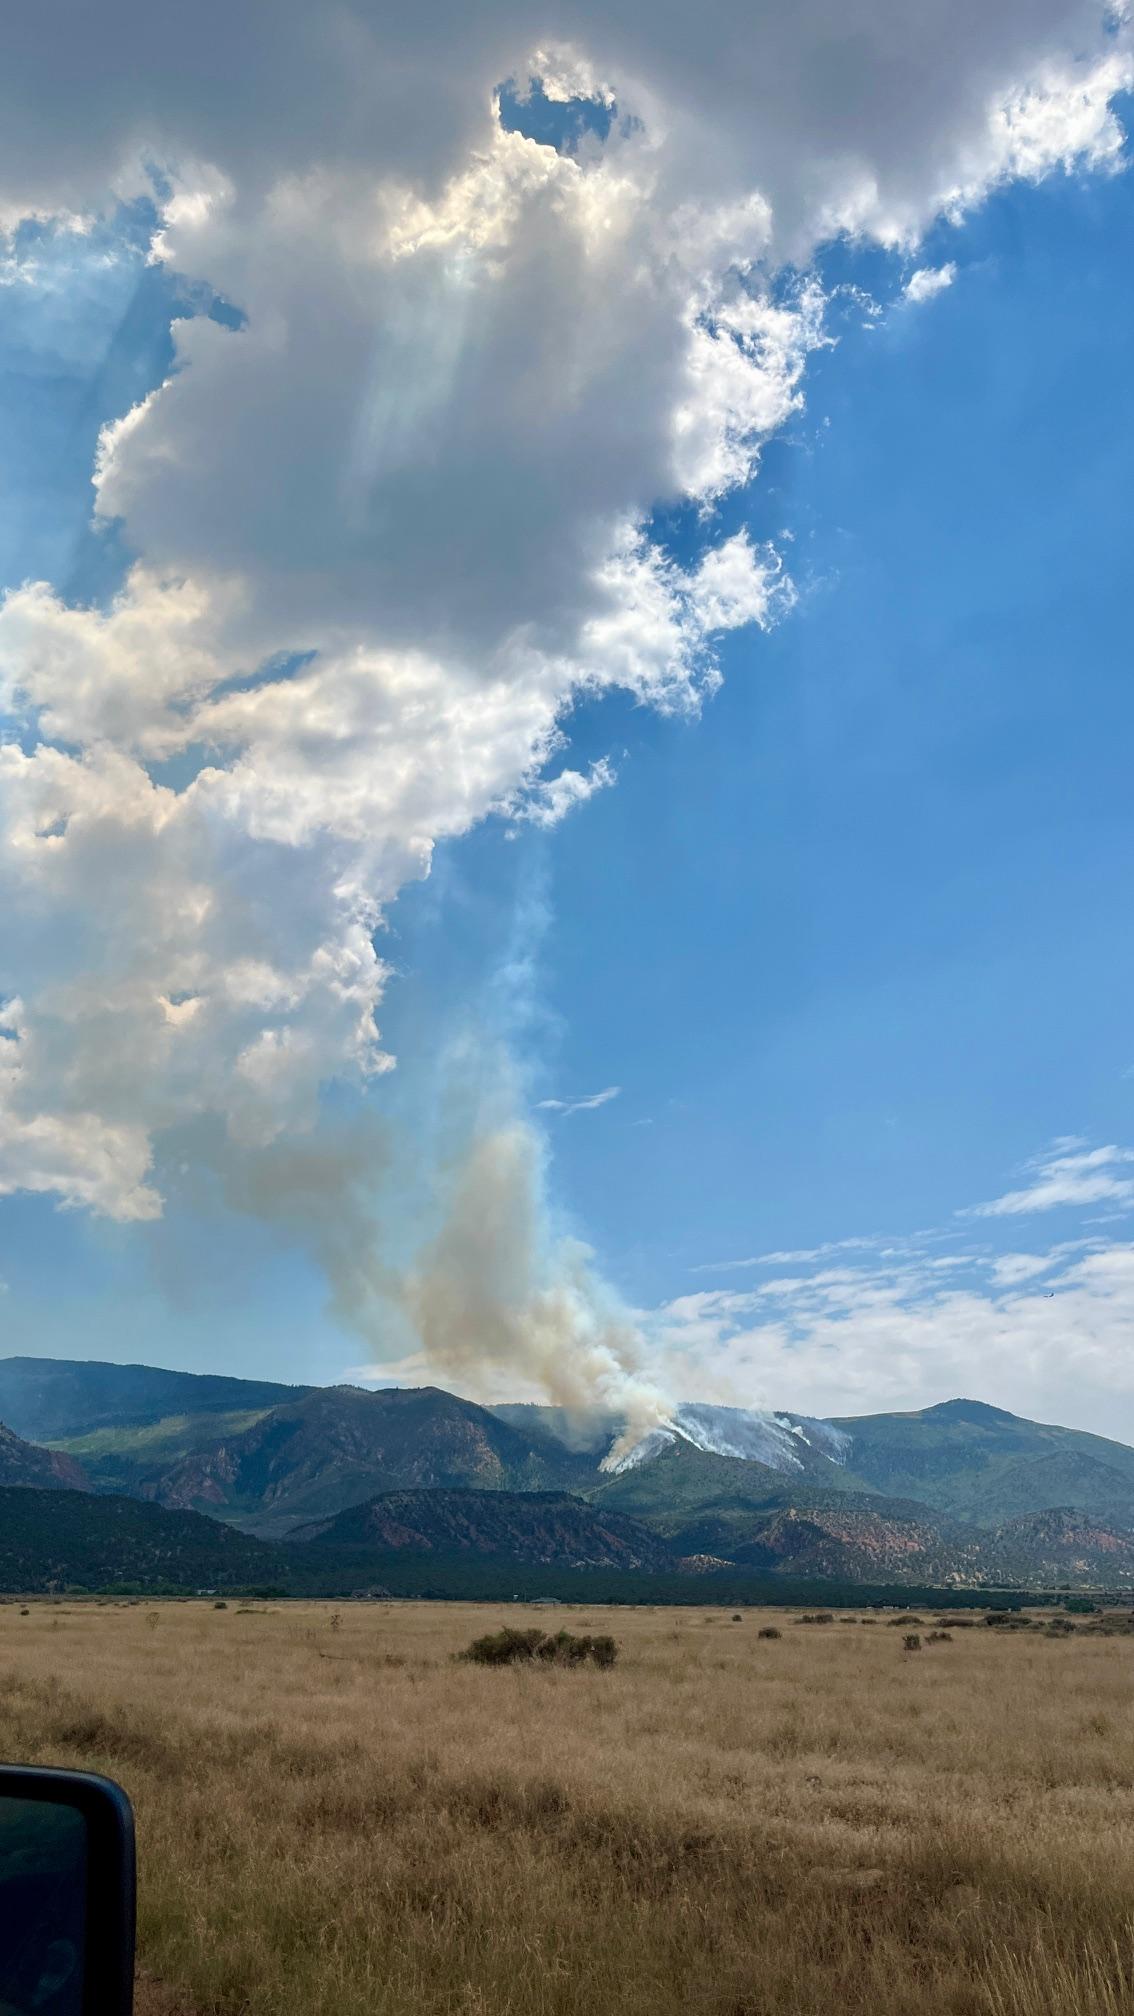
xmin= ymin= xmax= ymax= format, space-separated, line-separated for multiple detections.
xmin=652 ymin=1240 xmax=1134 ymax=1439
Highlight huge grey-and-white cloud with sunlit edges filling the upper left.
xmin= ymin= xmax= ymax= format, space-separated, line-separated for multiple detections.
xmin=0 ymin=0 xmax=1130 ymax=1395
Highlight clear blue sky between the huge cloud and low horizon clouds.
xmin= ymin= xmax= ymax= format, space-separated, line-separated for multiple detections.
xmin=375 ymin=161 xmax=1134 ymax=1407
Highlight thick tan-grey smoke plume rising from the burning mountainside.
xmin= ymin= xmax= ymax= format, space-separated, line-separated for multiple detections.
xmin=207 ymin=1088 xmax=674 ymax=1460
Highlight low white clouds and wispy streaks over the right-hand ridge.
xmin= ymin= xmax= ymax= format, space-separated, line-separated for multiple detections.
xmin=652 ymin=1139 xmax=1134 ymax=1439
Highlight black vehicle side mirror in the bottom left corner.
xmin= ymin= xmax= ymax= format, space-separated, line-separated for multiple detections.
xmin=0 ymin=1764 xmax=135 ymax=2016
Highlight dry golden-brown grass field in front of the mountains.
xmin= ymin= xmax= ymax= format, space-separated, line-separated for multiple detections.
xmin=0 ymin=1603 xmax=1134 ymax=2016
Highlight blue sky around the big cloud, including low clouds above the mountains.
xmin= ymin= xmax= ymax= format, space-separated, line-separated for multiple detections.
xmin=0 ymin=7 xmax=1134 ymax=1435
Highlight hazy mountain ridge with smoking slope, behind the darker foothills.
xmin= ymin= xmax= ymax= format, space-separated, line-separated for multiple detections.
xmin=0 ymin=1359 xmax=1134 ymax=1583
